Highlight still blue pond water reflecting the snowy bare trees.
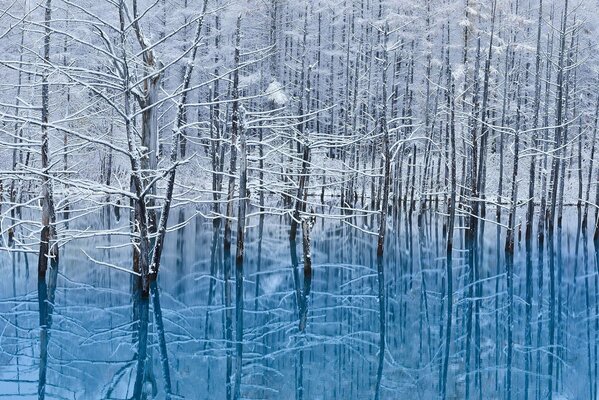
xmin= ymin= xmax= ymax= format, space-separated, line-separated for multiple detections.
xmin=0 ymin=208 xmax=599 ymax=399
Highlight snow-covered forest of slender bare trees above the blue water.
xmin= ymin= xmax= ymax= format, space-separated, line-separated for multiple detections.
xmin=0 ymin=0 xmax=599 ymax=245
